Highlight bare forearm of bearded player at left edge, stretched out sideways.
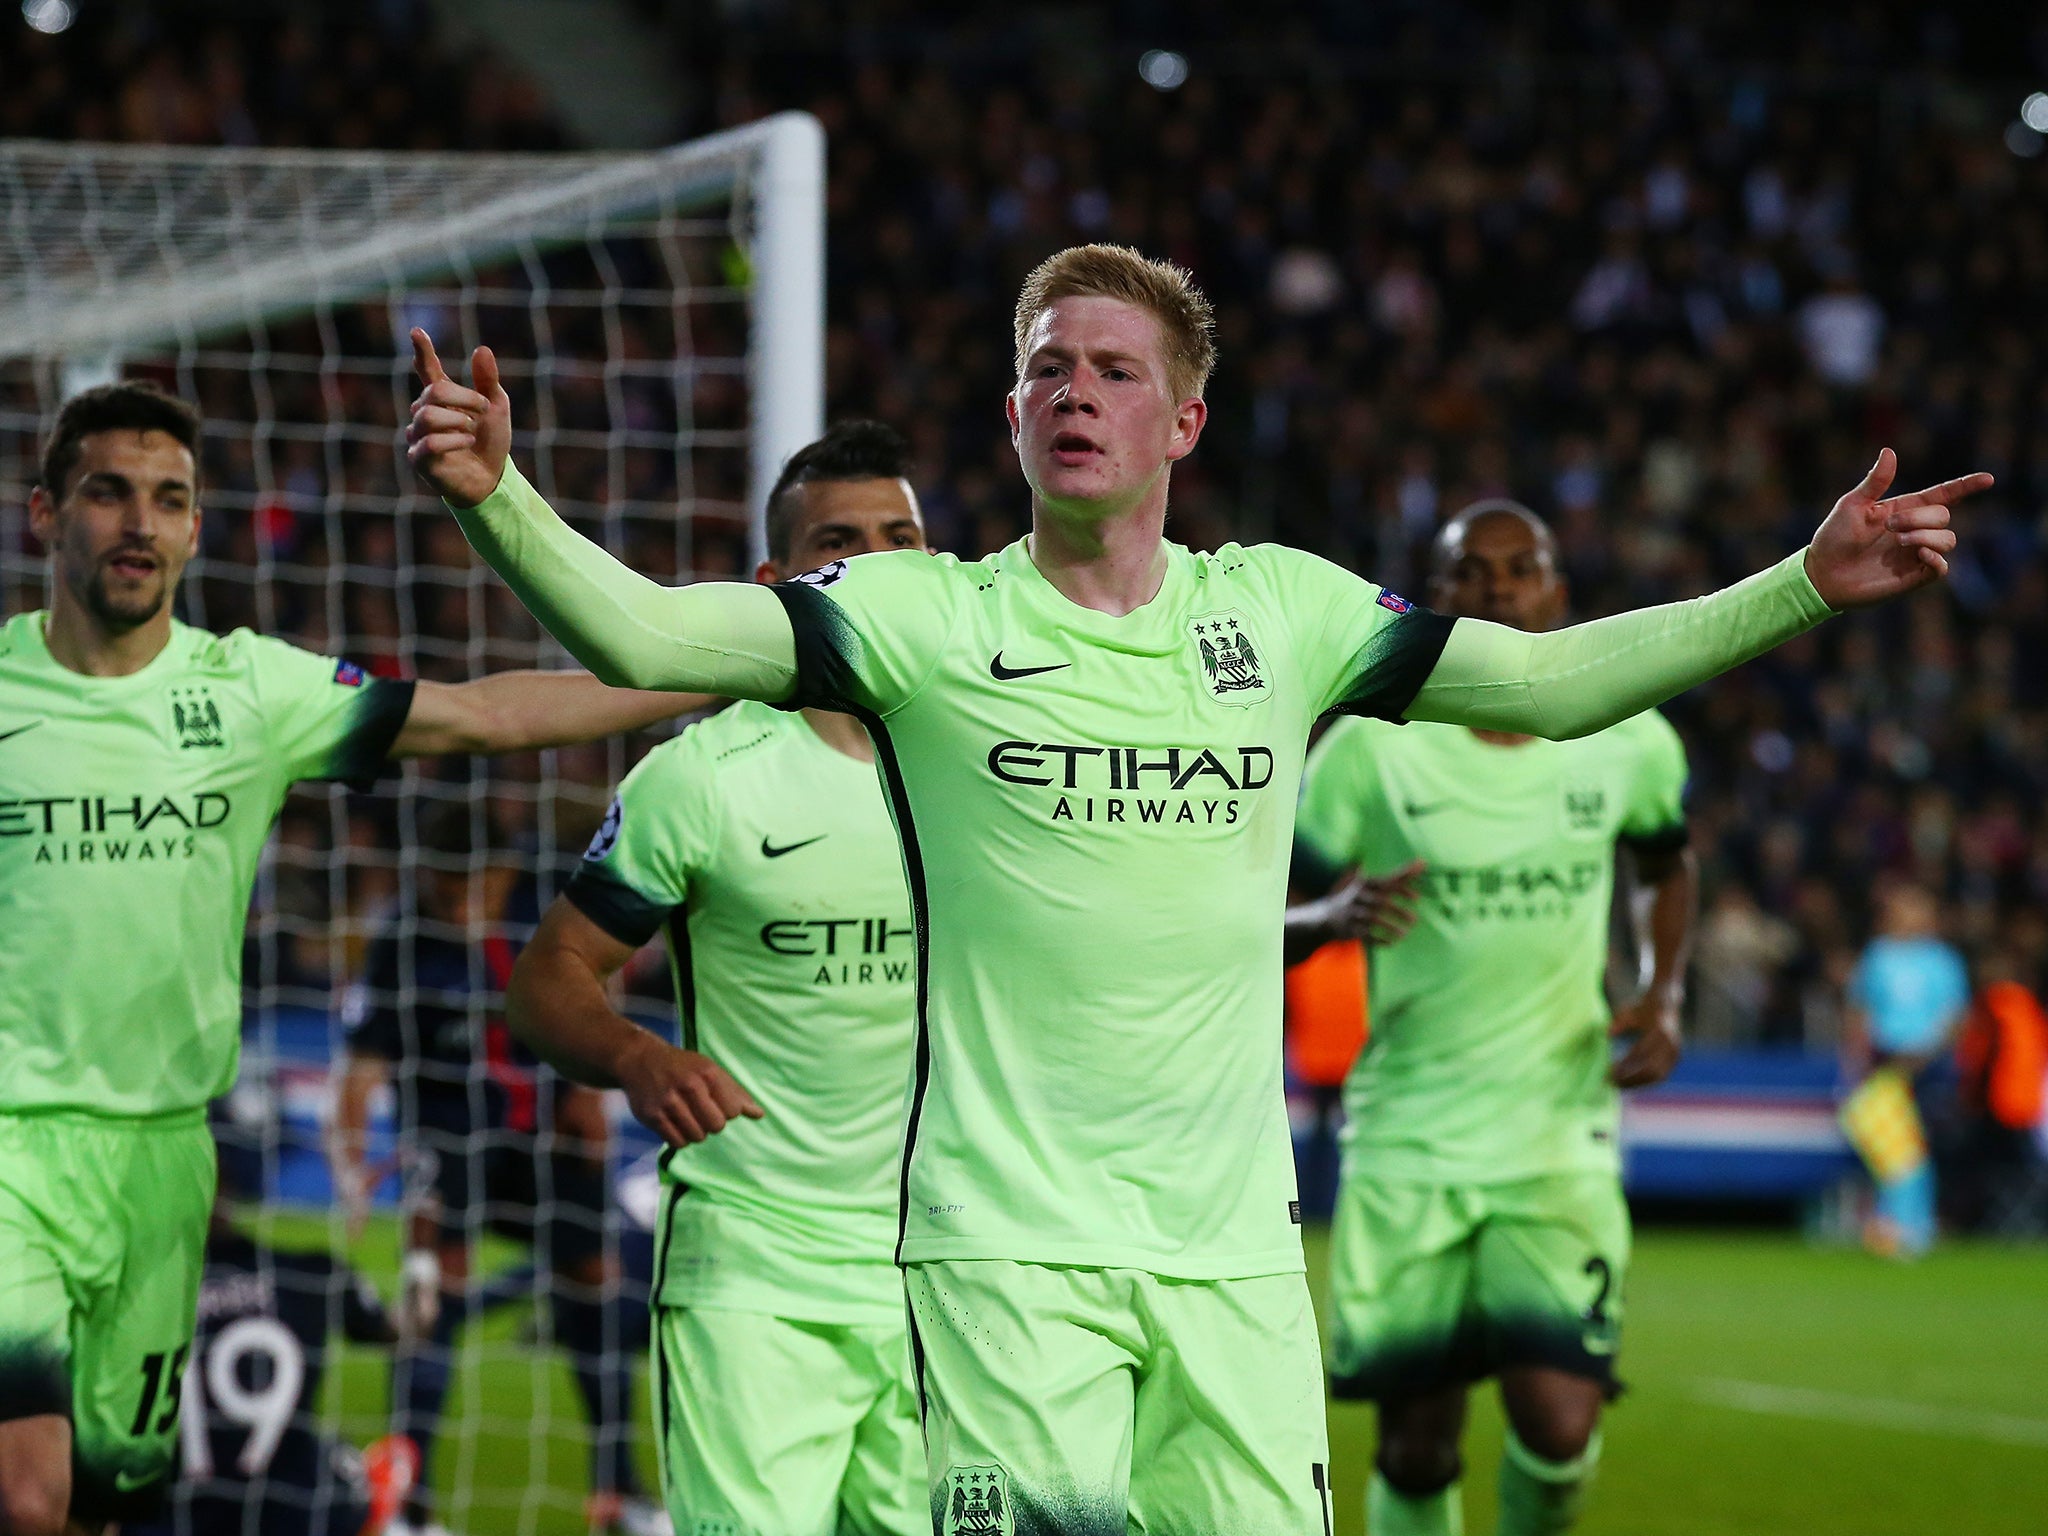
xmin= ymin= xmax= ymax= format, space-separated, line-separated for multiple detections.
xmin=391 ymin=672 xmax=719 ymax=758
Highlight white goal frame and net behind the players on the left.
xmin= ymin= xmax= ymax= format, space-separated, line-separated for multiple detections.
xmin=0 ymin=115 xmax=823 ymax=1536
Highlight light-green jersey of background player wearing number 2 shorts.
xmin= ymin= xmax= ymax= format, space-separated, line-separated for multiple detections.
xmin=1300 ymin=711 xmax=1686 ymax=1184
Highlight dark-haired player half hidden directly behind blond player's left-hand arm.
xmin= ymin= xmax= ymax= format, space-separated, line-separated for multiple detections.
xmin=510 ymin=422 xmax=932 ymax=1536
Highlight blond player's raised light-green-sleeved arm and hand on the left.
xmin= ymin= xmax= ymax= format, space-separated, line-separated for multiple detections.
xmin=406 ymin=330 xmax=797 ymax=705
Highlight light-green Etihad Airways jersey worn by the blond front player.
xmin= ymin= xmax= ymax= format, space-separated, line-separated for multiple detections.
xmin=776 ymin=541 xmax=1450 ymax=1280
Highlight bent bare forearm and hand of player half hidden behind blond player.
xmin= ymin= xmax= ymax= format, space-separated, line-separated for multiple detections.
xmin=506 ymin=897 xmax=764 ymax=1147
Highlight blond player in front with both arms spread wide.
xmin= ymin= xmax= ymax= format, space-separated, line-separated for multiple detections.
xmin=412 ymin=246 xmax=1989 ymax=1536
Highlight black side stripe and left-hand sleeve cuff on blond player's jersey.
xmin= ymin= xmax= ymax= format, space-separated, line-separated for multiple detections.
xmin=770 ymin=582 xmax=932 ymax=1264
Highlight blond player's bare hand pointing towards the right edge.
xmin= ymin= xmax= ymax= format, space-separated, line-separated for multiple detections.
xmin=1806 ymin=449 xmax=1991 ymax=608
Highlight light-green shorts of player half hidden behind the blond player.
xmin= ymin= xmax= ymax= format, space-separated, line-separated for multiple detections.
xmin=653 ymin=1307 xmax=930 ymax=1536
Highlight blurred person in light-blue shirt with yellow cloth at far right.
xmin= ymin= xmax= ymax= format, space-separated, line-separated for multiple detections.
xmin=1843 ymin=881 xmax=1970 ymax=1257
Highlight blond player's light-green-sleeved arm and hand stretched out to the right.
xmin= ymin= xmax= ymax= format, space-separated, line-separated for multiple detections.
xmin=1407 ymin=449 xmax=1991 ymax=739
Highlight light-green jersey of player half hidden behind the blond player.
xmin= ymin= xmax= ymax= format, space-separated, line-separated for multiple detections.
xmin=567 ymin=702 xmax=918 ymax=1323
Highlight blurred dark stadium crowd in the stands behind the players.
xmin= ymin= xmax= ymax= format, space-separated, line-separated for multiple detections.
xmin=0 ymin=0 xmax=2048 ymax=1049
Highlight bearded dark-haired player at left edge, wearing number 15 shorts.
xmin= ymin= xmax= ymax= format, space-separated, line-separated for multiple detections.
xmin=0 ymin=383 xmax=712 ymax=1536
